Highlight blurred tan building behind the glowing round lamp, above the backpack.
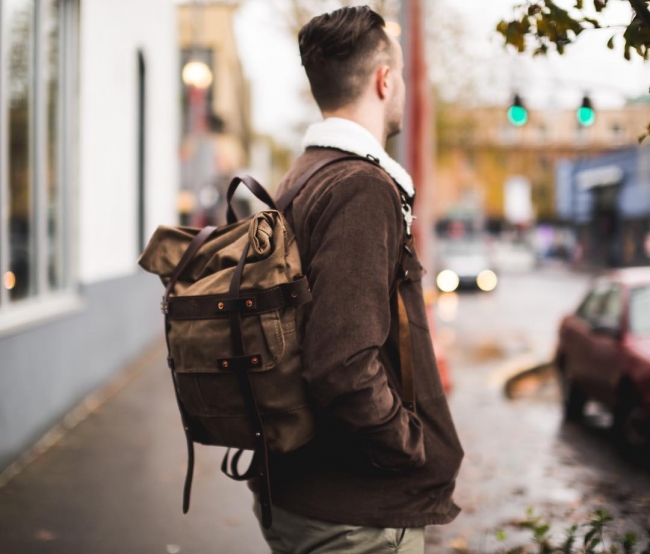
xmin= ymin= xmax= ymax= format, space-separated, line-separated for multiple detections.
xmin=177 ymin=0 xmax=254 ymax=226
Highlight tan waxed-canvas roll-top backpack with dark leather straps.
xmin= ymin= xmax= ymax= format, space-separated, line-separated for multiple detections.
xmin=138 ymin=152 xmax=415 ymax=529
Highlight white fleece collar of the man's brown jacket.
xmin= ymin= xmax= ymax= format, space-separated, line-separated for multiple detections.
xmin=302 ymin=117 xmax=415 ymax=197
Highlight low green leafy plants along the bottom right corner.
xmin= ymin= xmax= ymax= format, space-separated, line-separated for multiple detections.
xmin=496 ymin=508 xmax=650 ymax=554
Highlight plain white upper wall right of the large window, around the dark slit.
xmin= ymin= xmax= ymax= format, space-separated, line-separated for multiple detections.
xmin=77 ymin=0 xmax=179 ymax=284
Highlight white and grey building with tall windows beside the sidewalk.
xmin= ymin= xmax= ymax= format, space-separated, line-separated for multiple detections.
xmin=0 ymin=0 xmax=179 ymax=470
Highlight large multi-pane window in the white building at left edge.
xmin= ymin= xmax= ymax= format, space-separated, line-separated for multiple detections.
xmin=0 ymin=0 xmax=76 ymax=319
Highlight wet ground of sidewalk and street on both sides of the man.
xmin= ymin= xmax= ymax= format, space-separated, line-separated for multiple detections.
xmin=0 ymin=269 xmax=650 ymax=554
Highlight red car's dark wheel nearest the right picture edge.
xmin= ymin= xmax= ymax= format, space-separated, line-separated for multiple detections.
xmin=614 ymin=383 xmax=650 ymax=461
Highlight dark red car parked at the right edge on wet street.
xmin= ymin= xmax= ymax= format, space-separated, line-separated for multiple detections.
xmin=555 ymin=267 xmax=650 ymax=459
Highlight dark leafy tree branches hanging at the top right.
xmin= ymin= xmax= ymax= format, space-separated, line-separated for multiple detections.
xmin=496 ymin=0 xmax=650 ymax=142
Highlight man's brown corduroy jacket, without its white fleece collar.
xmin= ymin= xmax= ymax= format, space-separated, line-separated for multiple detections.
xmin=249 ymin=148 xmax=464 ymax=527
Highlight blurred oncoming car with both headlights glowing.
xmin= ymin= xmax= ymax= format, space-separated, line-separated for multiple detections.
xmin=435 ymin=238 xmax=497 ymax=292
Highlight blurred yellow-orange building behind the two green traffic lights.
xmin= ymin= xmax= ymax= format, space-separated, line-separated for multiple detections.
xmin=435 ymin=102 xmax=650 ymax=227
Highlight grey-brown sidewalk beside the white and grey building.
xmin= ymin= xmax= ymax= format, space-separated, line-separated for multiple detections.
xmin=0 ymin=342 xmax=269 ymax=554
